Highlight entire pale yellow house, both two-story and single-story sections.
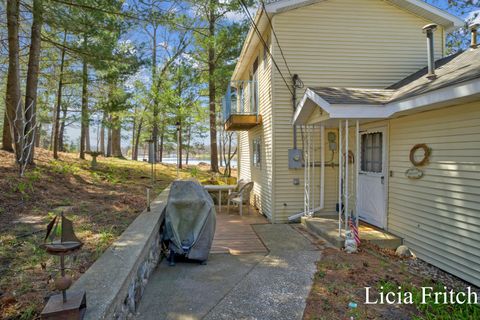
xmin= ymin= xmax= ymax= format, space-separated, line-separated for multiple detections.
xmin=224 ymin=0 xmax=480 ymax=285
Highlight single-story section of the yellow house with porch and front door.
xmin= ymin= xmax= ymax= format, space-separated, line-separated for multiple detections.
xmin=293 ymin=45 xmax=480 ymax=286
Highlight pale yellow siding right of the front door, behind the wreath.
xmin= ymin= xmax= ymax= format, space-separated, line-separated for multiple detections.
xmin=388 ymin=102 xmax=480 ymax=286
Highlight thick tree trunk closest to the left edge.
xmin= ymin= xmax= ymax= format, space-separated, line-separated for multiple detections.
xmin=3 ymin=0 xmax=23 ymax=162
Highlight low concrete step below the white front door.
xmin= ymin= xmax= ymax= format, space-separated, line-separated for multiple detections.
xmin=302 ymin=217 xmax=403 ymax=249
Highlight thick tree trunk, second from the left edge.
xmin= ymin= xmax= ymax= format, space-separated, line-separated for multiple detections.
xmin=23 ymin=0 xmax=43 ymax=164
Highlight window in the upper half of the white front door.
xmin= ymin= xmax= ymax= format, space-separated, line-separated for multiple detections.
xmin=361 ymin=132 xmax=383 ymax=173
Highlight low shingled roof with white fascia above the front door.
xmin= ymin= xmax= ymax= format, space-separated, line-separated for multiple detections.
xmin=293 ymin=49 xmax=480 ymax=125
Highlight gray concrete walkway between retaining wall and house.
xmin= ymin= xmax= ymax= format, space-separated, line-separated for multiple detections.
xmin=136 ymin=224 xmax=320 ymax=320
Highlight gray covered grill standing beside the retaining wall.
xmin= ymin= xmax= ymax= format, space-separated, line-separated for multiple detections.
xmin=164 ymin=180 xmax=216 ymax=261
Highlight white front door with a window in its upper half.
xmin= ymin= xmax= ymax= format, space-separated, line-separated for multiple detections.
xmin=358 ymin=127 xmax=387 ymax=228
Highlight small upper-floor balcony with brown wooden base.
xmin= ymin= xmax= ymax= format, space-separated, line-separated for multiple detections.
xmin=223 ymin=80 xmax=262 ymax=131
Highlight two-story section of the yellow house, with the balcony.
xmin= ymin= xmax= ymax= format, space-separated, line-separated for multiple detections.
xmin=224 ymin=0 xmax=463 ymax=223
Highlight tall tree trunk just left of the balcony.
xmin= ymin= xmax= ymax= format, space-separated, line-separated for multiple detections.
xmin=208 ymin=0 xmax=218 ymax=172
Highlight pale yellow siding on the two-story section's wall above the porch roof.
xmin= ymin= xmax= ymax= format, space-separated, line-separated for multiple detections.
xmin=272 ymin=0 xmax=443 ymax=222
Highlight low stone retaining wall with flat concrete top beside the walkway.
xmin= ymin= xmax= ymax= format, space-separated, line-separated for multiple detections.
xmin=70 ymin=188 xmax=170 ymax=320
